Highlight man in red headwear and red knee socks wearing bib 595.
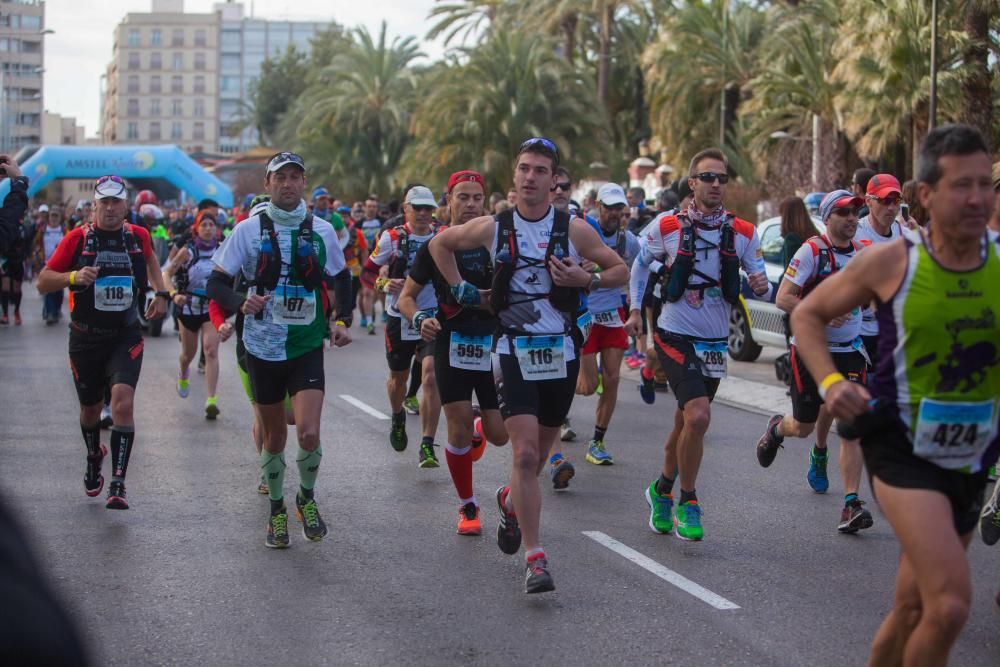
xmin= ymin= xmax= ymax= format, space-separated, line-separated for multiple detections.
xmin=399 ymin=171 xmax=507 ymax=535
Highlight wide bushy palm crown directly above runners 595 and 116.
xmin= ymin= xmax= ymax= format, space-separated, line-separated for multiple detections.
xmin=405 ymin=30 xmax=604 ymax=189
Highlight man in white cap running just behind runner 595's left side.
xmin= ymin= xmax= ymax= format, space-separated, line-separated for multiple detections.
xmin=361 ymin=185 xmax=441 ymax=468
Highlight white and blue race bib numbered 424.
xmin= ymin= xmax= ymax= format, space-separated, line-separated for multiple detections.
xmin=913 ymin=398 xmax=996 ymax=470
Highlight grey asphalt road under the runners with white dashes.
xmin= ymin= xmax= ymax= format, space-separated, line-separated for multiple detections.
xmin=0 ymin=286 xmax=1000 ymax=667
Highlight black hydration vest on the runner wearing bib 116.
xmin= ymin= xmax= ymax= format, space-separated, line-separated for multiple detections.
xmin=490 ymin=209 xmax=580 ymax=318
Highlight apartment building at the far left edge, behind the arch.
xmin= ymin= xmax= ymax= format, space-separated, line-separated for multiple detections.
xmin=0 ymin=0 xmax=51 ymax=153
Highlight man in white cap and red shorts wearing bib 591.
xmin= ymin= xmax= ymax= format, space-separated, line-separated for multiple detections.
xmin=576 ymin=183 xmax=639 ymax=465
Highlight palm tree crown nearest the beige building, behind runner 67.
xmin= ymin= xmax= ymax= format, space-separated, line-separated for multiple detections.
xmin=285 ymin=21 xmax=423 ymax=201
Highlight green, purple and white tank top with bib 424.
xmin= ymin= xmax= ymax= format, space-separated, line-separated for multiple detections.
xmin=873 ymin=236 xmax=1000 ymax=473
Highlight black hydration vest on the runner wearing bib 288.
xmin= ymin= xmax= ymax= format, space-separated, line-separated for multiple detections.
xmin=660 ymin=213 xmax=740 ymax=305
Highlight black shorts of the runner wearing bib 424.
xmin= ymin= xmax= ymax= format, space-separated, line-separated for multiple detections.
xmin=861 ymin=425 xmax=987 ymax=535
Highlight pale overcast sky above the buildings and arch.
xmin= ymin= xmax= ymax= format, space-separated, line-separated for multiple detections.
xmin=44 ymin=0 xmax=444 ymax=137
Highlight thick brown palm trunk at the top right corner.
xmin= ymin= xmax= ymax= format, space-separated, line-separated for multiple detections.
xmin=961 ymin=0 xmax=993 ymax=147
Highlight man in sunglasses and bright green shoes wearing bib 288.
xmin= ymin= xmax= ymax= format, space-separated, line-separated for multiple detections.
xmin=627 ymin=148 xmax=771 ymax=540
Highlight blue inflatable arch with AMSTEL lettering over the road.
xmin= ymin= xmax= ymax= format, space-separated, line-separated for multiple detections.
xmin=0 ymin=145 xmax=233 ymax=208
